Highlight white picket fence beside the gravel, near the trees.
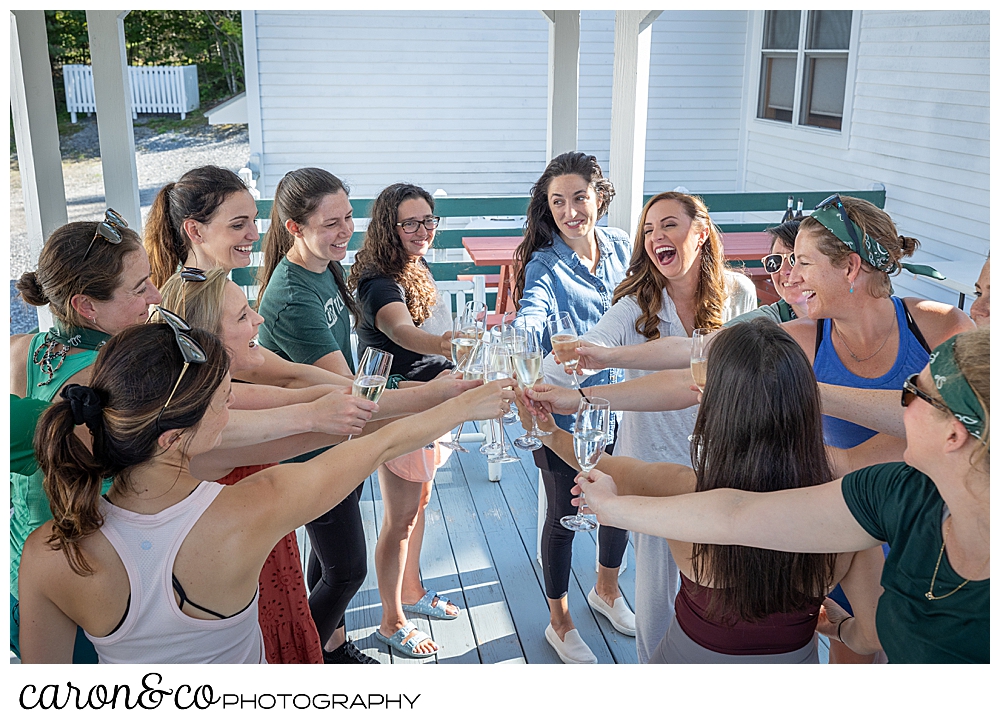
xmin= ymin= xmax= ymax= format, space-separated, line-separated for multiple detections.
xmin=63 ymin=65 xmax=199 ymax=123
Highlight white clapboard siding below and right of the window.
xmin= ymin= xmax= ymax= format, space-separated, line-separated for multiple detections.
xmin=745 ymin=10 xmax=990 ymax=303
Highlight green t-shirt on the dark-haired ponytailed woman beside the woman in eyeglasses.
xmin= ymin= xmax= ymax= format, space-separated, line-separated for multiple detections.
xmin=259 ymin=258 xmax=354 ymax=371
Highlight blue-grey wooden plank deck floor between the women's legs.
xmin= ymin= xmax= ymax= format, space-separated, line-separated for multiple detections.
xmin=332 ymin=423 xmax=636 ymax=664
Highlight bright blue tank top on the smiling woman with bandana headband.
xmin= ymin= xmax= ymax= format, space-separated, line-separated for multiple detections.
xmin=813 ymin=297 xmax=930 ymax=449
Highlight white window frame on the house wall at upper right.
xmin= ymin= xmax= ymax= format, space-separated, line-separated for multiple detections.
xmin=746 ymin=10 xmax=862 ymax=148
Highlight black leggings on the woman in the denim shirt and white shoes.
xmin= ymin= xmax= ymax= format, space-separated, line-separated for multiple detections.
xmin=534 ymin=443 xmax=628 ymax=599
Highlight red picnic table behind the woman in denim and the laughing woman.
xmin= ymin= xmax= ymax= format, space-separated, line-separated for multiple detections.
xmin=462 ymin=231 xmax=777 ymax=314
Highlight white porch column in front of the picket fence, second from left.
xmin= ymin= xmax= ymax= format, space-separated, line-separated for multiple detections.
xmin=87 ymin=10 xmax=142 ymax=233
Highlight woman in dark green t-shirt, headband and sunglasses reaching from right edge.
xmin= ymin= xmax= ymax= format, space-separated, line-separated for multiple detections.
xmin=574 ymin=328 xmax=990 ymax=663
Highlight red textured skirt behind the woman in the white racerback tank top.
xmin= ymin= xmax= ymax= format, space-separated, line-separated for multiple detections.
xmin=218 ymin=465 xmax=323 ymax=664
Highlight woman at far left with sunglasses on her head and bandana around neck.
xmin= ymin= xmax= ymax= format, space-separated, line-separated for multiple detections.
xmin=10 ymin=215 xmax=160 ymax=663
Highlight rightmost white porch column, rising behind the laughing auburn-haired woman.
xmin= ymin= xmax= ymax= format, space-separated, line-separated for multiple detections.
xmin=608 ymin=10 xmax=662 ymax=234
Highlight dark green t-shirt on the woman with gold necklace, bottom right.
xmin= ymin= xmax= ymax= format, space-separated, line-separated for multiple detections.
xmin=841 ymin=463 xmax=990 ymax=664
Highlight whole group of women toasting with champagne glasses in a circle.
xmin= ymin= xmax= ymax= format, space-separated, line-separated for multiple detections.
xmin=11 ymin=153 xmax=989 ymax=663
